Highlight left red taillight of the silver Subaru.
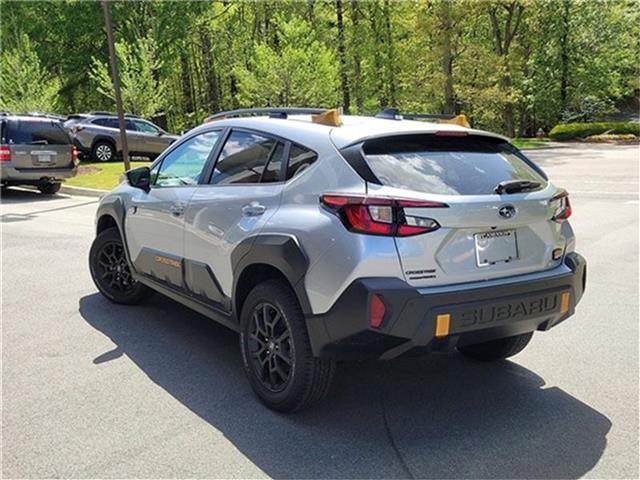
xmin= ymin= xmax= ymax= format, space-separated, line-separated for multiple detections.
xmin=320 ymin=194 xmax=448 ymax=237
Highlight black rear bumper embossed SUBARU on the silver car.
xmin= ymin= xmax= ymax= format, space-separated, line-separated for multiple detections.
xmin=307 ymin=253 xmax=586 ymax=359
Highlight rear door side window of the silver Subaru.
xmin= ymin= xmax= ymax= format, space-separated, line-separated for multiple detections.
xmin=211 ymin=131 xmax=284 ymax=185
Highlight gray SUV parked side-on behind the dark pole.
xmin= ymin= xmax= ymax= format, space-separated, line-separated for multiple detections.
xmin=64 ymin=112 xmax=178 ymax=162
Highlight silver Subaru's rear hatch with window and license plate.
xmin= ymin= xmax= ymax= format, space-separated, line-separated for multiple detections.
xmin=363 ymin=134 xmax=565 ymax=287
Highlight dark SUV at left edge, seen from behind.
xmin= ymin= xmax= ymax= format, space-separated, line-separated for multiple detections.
xmin=0 ymin=114 xmax=78 ymax=194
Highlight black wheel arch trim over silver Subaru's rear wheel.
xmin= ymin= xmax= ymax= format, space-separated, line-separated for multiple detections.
xmin=231 ymin=234 xmax=312 ymax=318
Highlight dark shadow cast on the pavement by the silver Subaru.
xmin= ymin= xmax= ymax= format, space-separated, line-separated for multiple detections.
xmin=80 ymin=293 xmax=611 ymax=478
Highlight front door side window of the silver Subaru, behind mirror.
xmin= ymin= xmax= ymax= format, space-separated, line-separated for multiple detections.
xmin=151 ymin=131 xmax=220 ymax=187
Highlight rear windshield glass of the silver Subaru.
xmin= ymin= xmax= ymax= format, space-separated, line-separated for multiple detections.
xmin=363 ymin=135 xmax=546 ymax=195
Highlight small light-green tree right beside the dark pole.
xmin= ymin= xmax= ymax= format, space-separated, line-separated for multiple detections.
xmin=89 ymin=37 xmax=166 ymax=117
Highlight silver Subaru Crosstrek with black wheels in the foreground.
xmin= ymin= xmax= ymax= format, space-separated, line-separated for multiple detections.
xmin=89 ymin=110 xmax=586 ymax=411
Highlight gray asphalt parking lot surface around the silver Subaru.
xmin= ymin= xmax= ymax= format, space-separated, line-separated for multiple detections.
xmin=1 ymin=145 xmax=640 ymax=478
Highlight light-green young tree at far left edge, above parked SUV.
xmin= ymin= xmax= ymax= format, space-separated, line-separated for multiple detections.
xmin=0 ymin=35 xmax=60 ymax=112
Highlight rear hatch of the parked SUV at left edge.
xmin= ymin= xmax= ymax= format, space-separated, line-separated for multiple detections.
xmin=5 ymin=118 xmax=74 ymax=170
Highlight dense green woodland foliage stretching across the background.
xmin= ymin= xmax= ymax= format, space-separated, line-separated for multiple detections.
xmin=0 ymin=0 xmax=640 ymax=135
